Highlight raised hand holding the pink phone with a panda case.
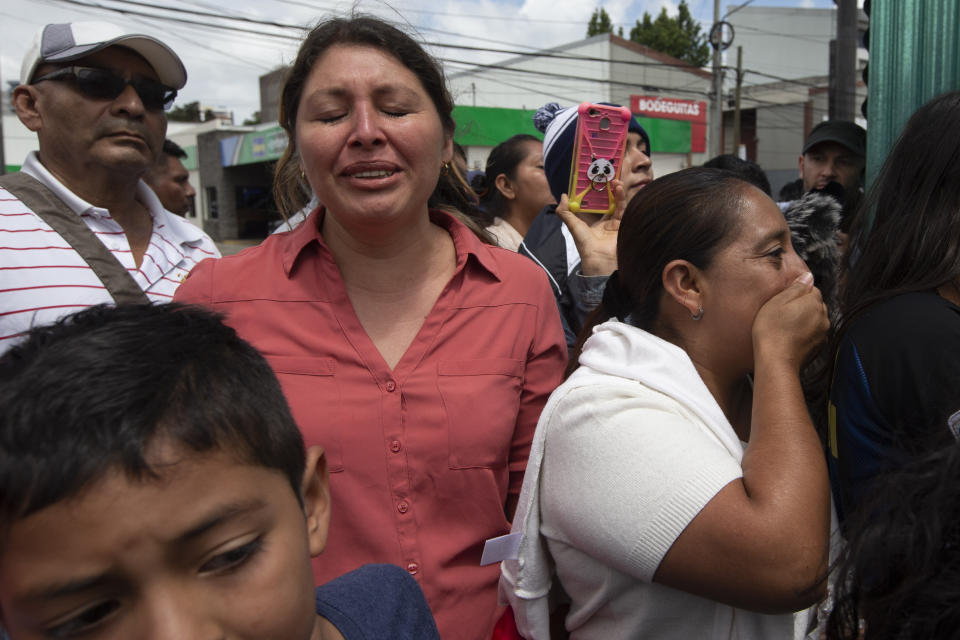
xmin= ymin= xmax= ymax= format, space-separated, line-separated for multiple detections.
xmin=557 ymin=180 xmax=627 ymax=276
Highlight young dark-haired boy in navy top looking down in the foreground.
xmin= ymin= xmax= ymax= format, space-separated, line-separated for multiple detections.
xmin=0 ymin=304 xmax=438 ymax=640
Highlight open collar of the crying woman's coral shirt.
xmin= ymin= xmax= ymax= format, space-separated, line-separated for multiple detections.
xmin=283 ymin=206 xmax=502 ymax=280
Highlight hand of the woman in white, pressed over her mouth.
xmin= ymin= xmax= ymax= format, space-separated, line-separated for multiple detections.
xmin=753 ymin=271 xmax=830 ymax=371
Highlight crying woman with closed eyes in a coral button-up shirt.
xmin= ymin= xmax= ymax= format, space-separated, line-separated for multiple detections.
xmin=178 ymin=17 xmax=566 ymax=640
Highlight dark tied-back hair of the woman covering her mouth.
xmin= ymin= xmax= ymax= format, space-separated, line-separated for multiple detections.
xmin=570 ymin=167 xmax=750 ymax=370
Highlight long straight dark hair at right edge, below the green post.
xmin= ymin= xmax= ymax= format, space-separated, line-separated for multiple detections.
xmin=838 ymin=91 xmax=960 ymax=335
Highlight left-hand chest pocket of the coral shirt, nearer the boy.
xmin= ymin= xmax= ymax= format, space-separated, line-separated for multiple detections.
xmin=266 ymin=356 xmax=345 ymax=473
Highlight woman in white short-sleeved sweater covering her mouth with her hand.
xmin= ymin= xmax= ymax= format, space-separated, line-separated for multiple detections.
xmin=501 ymin=168 xmax=830 ymax=640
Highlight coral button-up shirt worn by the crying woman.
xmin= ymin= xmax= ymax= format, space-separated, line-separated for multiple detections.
xmin=176 ymin=209 xmax=567 ymax=640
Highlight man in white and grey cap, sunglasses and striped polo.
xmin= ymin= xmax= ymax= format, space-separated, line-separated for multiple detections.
xmin=0 ymin=22 xmax=219 ymax=352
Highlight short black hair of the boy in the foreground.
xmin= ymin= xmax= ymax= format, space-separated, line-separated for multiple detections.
xmin=0 ymin=303 xmax=305 ymax=534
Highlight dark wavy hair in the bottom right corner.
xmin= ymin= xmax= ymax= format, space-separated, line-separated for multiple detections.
xmin=827 ymin=443 xmax=960 ymax=640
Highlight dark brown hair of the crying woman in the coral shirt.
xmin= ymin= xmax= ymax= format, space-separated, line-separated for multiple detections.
xmin=273 ymin=15 xmax=462 ymax=216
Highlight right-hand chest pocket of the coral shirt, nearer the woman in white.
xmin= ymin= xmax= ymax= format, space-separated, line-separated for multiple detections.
xmin=437 ymin=358 xmax=524 ymax=469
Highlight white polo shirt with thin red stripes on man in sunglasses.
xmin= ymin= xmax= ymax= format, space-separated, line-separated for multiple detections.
xmin=0 ymin=152 xmax=220 ymax=353
